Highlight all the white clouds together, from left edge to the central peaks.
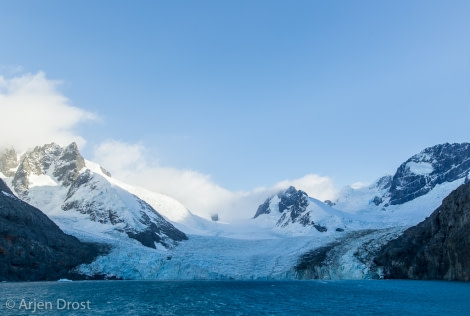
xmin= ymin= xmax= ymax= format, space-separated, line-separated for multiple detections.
xmin=0 ymin=72 xmax=337 ymax=220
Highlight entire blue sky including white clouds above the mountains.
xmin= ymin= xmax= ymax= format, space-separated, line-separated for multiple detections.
xmin=0 ymin=0 xmax=470 ymax=220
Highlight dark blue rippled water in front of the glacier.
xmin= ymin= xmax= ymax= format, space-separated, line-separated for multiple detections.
xmin=0 ymin=280 xmax=470 ymax=316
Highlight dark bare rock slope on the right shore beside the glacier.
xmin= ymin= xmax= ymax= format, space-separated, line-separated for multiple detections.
xmin=374 ymin=184 xmax=470 ymax=281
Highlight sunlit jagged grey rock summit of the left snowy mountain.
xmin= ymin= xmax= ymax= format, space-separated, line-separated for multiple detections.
xmin=12 ymin=143 xmax=85 ymax=199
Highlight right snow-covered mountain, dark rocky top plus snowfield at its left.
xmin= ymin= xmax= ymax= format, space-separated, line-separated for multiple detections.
xmin=333 ymin=143 xmax=470 ymax=220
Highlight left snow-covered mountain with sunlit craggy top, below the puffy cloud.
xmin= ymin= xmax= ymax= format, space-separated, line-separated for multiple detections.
xmin=0 ymin=143 xmax=187 ymax=248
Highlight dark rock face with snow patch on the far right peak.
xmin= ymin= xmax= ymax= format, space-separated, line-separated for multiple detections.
xmin=389 ymin=143 xmax=470 ymax=205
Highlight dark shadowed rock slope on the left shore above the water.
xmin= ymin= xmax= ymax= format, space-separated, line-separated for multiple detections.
xmin=0 ymin=179 xmax=106 ymax=281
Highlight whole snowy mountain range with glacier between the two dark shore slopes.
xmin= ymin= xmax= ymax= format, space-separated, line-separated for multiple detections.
xmin=0 ymin=144 xmax=470 ymax=279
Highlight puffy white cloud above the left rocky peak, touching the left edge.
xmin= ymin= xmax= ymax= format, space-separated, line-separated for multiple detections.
xmin=0 ymin=72 xmax=95 ymax=151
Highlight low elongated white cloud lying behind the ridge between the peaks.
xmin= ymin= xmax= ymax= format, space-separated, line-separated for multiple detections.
xmin=93 ymin=140 xmax=337 ymax=221
